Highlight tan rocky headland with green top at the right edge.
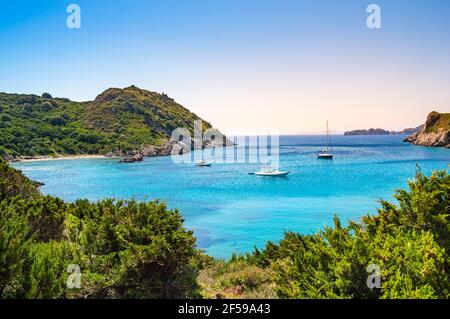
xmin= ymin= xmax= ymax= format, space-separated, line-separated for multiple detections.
xmin=405 ymin=112 xmax=450 ymax=148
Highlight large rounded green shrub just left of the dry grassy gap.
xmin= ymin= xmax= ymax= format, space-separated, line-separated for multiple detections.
xmin=69 ymin=200 xmax=197 ymax=298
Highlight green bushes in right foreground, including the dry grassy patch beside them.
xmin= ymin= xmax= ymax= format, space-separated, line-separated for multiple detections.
xmin=200 ymin=172 xmax=450 ymax=298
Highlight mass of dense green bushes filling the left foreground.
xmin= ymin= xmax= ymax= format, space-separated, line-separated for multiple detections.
xmin=0 ymin=160 xmax=198 ymax=298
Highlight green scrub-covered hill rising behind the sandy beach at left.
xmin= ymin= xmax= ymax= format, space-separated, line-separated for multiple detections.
xmin=0 ymin=86 xmax=211 ymax=157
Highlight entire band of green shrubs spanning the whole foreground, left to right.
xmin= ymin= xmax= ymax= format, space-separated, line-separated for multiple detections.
xmin=0 ymin=159 xmax=450 ymax=298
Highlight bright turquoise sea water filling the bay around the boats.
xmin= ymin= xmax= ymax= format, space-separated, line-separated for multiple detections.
xmin=14 ymin=136 xmax=450 ymax=257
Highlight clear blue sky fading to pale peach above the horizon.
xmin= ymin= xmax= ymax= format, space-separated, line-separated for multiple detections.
xmin=0 ymin=0 xmax=450 ymax=134
